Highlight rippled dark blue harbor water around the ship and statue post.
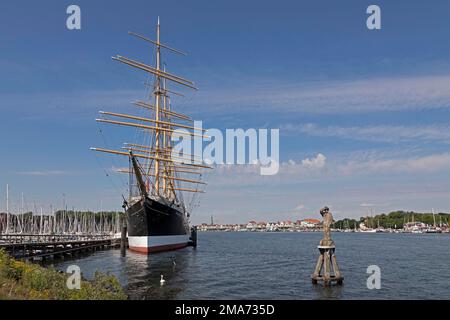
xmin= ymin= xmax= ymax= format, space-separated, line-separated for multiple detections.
xmin=46 ymin=232 xmax=450 ymax=299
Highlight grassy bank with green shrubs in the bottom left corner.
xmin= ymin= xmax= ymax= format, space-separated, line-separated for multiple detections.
xmin=0 ymin=250 xmax=127 ymax=300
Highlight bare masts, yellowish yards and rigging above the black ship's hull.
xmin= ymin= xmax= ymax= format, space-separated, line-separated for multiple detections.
xmin=91 ymin=17 xmax=212 ymax=203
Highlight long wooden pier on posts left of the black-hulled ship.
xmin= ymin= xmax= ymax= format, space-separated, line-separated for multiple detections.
xmin=0 ymin=234 xmax=121 ymax=259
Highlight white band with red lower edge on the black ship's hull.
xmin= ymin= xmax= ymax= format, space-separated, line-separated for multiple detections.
xmin=128 ymin=234 xmax=189 ymax=253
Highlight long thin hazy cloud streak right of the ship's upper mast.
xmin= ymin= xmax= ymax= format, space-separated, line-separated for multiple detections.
xmin=188 ymin=75 xmax=450 ymax=115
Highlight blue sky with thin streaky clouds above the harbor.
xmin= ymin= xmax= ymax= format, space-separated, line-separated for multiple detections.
xmin=0 ymin=0 xmax=450 ymax=223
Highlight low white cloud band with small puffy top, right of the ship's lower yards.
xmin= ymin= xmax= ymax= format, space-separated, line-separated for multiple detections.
xmin=206 ymin=152 xmax=450 ymax=190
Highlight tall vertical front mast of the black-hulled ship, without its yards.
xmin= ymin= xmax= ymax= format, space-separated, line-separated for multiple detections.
xmin=155 ymin=17 xmax=161 ymax=195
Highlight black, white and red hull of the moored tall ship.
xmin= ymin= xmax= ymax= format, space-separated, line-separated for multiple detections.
xmin=127 ymin=197 xmax=189 ymax=253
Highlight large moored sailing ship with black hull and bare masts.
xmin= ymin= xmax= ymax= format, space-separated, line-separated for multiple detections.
xmin=91 ymin=17 xmax=211 ymax=253
